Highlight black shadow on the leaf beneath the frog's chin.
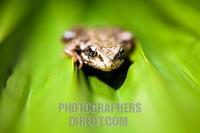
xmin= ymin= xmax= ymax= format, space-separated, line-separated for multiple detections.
xmin=79 ymin=60 xmax=133 ymax=90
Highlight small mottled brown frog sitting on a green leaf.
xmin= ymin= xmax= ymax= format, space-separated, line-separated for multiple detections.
xmin=62 ymin=27 xmax=135 ymax=72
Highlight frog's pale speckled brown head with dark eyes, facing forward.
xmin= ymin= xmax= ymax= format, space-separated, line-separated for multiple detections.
xmin=81 ymin=44 xmax=125 ymax=71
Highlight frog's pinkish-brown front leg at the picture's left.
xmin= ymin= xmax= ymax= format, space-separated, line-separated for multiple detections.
xmin=64 ymin=45 xmax=83 ymax=69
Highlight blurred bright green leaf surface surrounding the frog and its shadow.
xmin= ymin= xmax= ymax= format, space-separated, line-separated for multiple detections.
xmin=0 ymin=0 xmax=200 ymax=133
